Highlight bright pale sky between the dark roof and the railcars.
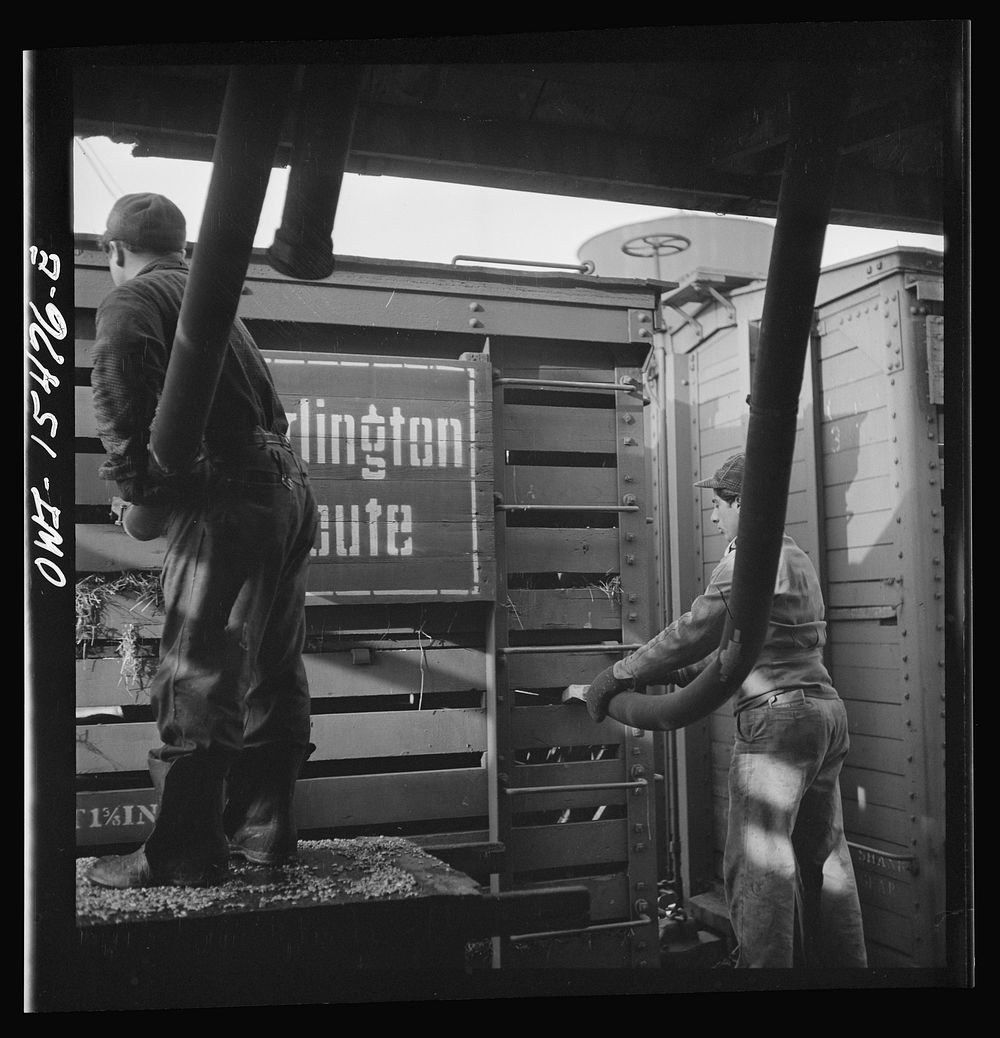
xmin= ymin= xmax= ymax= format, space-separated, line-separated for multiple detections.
xmin=74 ymin=137 xmax=944 ymax=274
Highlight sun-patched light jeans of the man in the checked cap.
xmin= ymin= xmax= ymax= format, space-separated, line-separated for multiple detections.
xmin=724 ymin=691 xmax=867 ymax=967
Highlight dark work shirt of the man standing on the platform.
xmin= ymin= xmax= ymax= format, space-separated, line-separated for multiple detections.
xmin=90 ymin=258 xmax=288 ymax=503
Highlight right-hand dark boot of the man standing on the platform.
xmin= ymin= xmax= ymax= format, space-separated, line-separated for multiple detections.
xmin=223 ymin=743 xmax=316 ymax=865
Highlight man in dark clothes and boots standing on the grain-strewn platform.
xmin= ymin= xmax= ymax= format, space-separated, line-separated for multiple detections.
xmin=87 ymin=192 xmax=318 ymax=887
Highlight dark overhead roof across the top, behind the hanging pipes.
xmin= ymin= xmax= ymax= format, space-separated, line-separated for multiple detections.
xmin=74 ymin=43 xmax=948 ymax=234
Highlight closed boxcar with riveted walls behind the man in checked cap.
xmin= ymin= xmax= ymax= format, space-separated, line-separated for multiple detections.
xmin=659 ymin=244 xmax=947 ymax=967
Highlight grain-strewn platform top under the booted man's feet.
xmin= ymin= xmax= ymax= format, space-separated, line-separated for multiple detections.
xmin=77 ymin=837 xmax=451 ymax=923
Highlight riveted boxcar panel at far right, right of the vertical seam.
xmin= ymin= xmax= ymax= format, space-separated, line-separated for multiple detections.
xmin=817 ymin=255 xmax=945 ymax=966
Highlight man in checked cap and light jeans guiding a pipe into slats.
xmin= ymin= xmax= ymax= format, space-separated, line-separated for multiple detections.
xmin=586 ymin=453 xmax=867 ymax=967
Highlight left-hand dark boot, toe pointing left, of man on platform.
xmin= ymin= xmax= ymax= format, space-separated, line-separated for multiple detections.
xmin=86 ymin=756 xmax=228 ymax=889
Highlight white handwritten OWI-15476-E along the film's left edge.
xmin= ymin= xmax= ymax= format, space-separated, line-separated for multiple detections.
xmin=27 ymin=245 xmax=66 ymax=588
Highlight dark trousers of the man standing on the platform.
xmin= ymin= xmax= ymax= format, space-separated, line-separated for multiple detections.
xmin=150 ymin=433 xmax=317 ymax=775
